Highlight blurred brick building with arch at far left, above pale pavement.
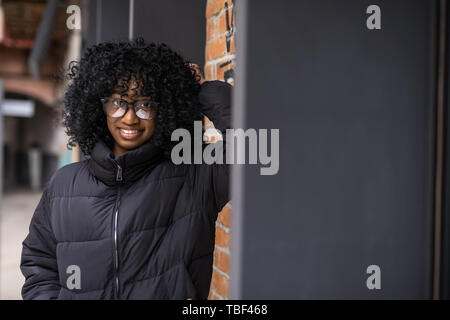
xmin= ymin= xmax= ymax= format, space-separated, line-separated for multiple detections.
xmin=0 ymin=0 xmax=78 ymax=191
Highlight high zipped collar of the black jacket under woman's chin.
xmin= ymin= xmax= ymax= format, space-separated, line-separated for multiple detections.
xmin=89 ymin=139 xmax=163 ymax=186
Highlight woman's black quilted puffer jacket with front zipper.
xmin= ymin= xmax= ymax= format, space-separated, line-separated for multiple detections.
xmin=21 ymin=81 xmax=231 ymax=299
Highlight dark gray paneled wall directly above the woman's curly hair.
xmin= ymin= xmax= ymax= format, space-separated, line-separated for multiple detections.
xmin=82 ymin=0 xmax=206 ymax=66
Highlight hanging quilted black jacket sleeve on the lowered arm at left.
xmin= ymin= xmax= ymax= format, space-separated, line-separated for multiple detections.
xmin=20 ymin=189 xmax=61 ymax=300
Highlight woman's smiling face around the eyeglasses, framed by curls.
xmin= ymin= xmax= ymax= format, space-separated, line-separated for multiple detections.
xmin=106 ymin=79 xmax=156 ymax=157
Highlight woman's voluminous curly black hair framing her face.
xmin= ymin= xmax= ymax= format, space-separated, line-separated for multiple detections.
xmin=62 ymin=38 xmax=203 ymax=157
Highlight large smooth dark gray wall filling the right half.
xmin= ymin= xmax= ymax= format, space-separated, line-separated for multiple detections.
xmin=231 ymin=0 xmax=436 ymax=299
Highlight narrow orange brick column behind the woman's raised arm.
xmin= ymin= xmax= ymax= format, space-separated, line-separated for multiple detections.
xmin=204 ymin=0 xmax=235 ymax=300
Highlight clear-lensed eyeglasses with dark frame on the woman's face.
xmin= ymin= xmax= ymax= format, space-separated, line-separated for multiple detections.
xmin=100 ymin=98 xmax=157 ymax=120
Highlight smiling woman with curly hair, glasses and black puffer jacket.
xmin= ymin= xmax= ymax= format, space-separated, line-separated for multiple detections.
xmin=21 ymin=39 xmax=231 ymax=299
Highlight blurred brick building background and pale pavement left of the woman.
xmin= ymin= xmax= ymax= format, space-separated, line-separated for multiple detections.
xmin=0 ymin=0 xmax=80 ymax=299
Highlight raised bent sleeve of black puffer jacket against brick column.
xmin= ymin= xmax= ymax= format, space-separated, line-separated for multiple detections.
xmin=199 ymin=80 xmax=232 ymax=219
